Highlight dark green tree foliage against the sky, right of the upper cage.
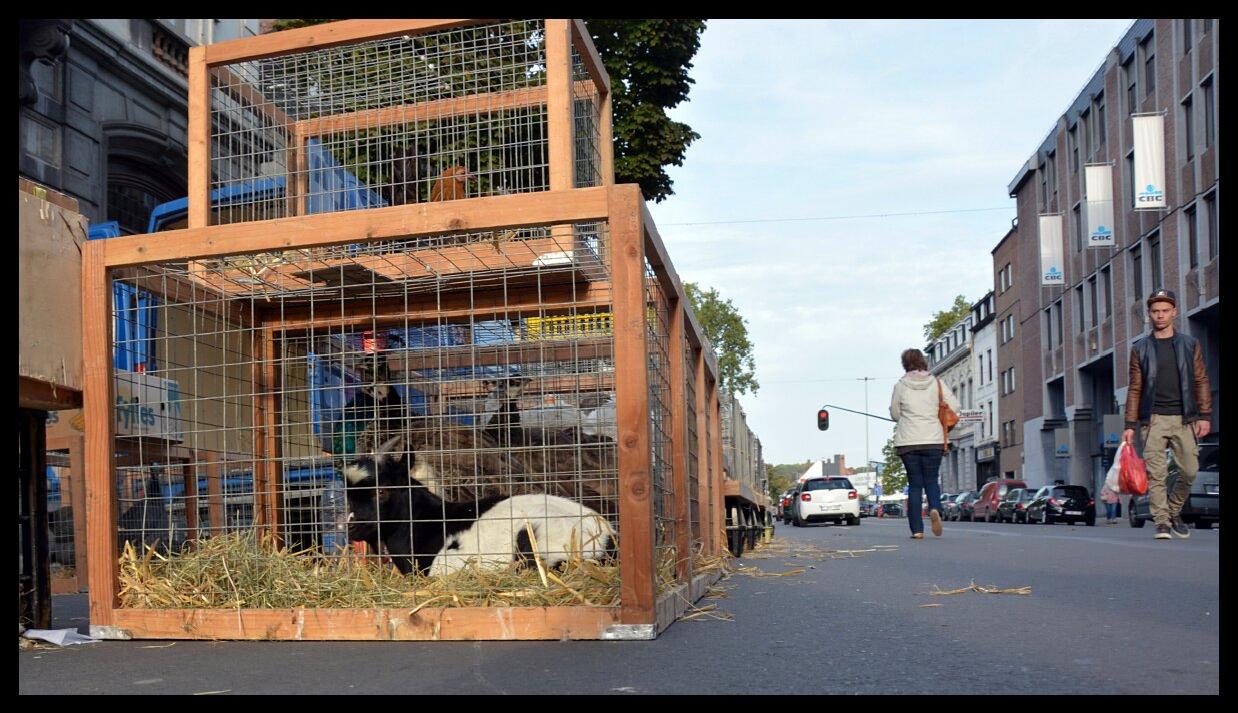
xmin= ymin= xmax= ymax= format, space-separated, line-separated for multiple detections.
xmin=586 ymin=20 xmax=704 ymax=203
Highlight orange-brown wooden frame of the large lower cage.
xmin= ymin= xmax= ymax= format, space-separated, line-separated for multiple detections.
xmin=83 ymin=179 xmax=724 ymax=640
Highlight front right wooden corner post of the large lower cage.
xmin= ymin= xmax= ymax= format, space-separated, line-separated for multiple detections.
xmin=608 ymin=186 xmax=656 ymax=624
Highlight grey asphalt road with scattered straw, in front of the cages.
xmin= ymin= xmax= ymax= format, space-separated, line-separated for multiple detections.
xmin=19 ymin=519 xmax=1221 ymax=694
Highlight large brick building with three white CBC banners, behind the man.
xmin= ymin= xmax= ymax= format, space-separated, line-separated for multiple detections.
xmin=993 ymin=19 xmax=1221 ymax=493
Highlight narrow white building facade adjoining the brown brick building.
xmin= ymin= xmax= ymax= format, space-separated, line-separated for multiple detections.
xmin=970 ymin=291 xmax=1002 ymax=485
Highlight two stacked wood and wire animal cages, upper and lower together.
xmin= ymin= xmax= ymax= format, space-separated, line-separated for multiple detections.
xmin=83 ymin=20 xmax=724 ymax=640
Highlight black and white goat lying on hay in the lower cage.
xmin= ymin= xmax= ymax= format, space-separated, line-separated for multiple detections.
xmin=344 ymin=438 xmax=615 ymax=576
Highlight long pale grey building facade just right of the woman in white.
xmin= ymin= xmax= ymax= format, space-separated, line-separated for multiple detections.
xmin=925 ymin=313 xmax=977 ymax=493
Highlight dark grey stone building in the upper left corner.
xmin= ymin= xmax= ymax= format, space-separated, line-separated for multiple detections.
xmin=17 ymin=20 xmax=260 ymax=234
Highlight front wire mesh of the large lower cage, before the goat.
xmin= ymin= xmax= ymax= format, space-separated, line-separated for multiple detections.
xmin=113 ymin=223 xmax=628 ymax=607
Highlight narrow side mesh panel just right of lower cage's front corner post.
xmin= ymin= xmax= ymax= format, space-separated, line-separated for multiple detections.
xmin=645 ymin=260 xmax=678 ymax=590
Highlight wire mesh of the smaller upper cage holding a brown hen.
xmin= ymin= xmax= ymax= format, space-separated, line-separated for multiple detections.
xmin=209 ymin=20 xmax=600 ymax=223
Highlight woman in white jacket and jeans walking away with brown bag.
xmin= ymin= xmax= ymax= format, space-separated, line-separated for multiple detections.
xmin=890 ymin=349 xmax=961 ymax=540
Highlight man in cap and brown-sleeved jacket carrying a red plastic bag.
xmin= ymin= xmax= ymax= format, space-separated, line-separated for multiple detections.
xmin=1122 ymin=290 xmax=1212 ymax=540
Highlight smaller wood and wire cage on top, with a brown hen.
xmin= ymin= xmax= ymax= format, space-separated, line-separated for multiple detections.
xmin=189 ymin=20 xmax=613 ymax=228
